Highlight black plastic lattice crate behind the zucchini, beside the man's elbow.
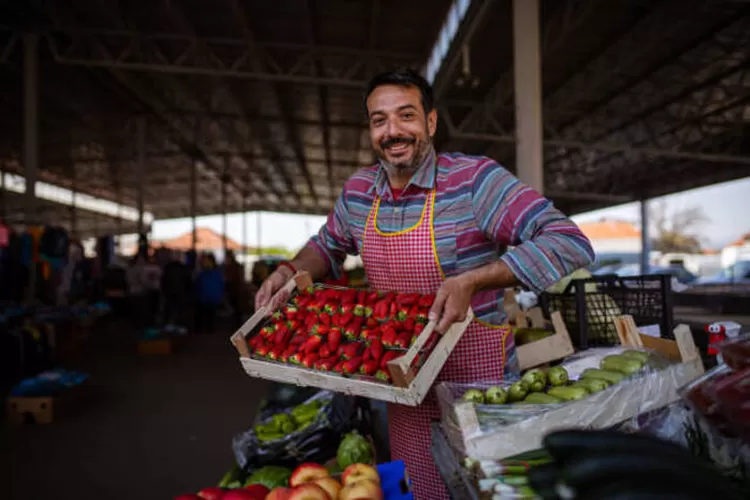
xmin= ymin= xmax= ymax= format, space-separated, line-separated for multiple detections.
xmin=540 ymin=274 xmax=674 ymax=349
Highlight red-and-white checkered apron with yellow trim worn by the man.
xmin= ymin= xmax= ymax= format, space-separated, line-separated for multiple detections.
xmin=361 ymin=191 xmax=512 ymax=500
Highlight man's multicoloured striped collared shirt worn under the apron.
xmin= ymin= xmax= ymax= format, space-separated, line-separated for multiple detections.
xmin=308 ymin=146 xmax=594 ymax=325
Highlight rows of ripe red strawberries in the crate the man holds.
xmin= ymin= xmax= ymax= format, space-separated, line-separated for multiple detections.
xmin=248 ymin=286 xmax=437 ymax=383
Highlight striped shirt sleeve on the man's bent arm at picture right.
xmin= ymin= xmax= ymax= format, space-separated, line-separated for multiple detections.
xmin=472 ymin=160 xmax=594 ymax=292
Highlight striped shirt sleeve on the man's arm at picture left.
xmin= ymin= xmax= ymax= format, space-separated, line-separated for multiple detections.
xmin=306 ymin=187 xmax=358 ymax=279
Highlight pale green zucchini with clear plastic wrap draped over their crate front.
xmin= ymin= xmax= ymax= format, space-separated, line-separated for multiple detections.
xmin=437 ymin=348 xmax=702 ymax=459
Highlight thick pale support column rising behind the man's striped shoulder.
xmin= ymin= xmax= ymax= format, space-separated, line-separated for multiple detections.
xmin=513 ymin=0 xmax=544 ymax=193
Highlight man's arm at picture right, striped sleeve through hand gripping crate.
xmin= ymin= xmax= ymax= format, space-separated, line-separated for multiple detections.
xmin=430 ymin=160 xmax=594 ymax=333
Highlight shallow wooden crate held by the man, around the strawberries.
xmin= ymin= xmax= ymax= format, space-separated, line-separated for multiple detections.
xmin=230 ymin=272 xmax=474 ymax=406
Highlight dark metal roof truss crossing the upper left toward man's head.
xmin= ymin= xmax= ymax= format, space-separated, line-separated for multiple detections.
xmin=22 ymin=24 xmax=421 ymax=88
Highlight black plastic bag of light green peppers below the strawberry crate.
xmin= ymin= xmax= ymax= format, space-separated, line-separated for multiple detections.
xmin=232 ymin=391 xmax=370 ymax=471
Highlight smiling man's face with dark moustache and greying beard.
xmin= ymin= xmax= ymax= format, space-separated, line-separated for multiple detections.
xmin=367 ymin=85 xmax=437 ymax=175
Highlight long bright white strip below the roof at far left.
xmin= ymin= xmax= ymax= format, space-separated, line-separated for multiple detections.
xmin=2 ymin=173 xmax=154 ymax=224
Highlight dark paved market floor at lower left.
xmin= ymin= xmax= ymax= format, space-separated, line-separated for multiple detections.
xmin=0 ymin=320 xmax=266 ymax=500
